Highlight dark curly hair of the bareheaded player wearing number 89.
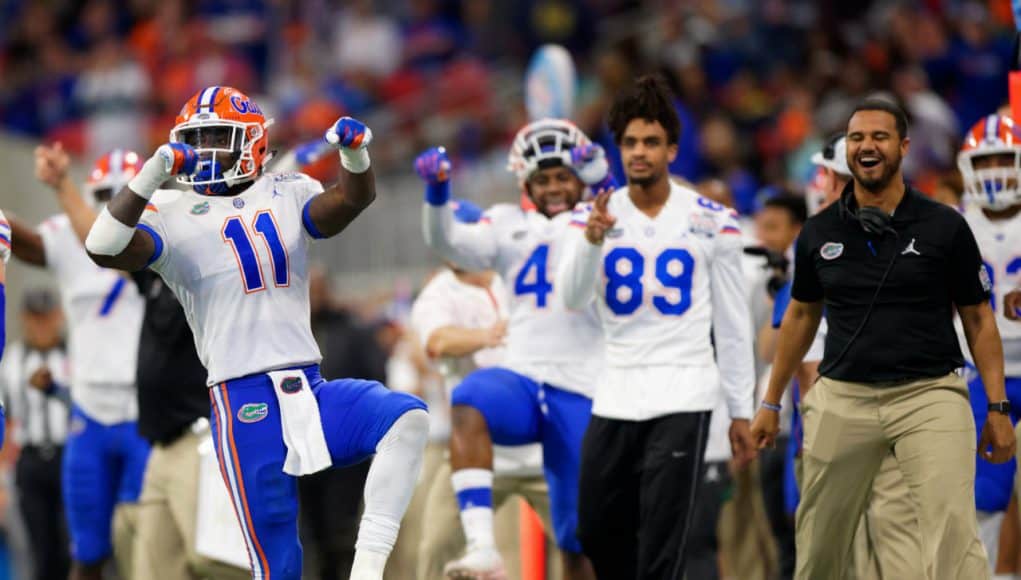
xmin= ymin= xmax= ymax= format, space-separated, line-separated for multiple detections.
xmin=610 ymin=75 xmax=681 ymax=145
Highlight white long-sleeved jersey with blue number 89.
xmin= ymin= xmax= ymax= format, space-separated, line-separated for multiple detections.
xmin=556 ymin=184 xmax=755 ymax=420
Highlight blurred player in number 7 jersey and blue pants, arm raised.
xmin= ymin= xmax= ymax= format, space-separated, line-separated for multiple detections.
xmin=10 ymin=143 xmax=149 ymax=579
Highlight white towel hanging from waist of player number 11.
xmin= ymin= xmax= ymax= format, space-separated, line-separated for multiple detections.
xmin=266 ymin=370 xmax=333 ymax=476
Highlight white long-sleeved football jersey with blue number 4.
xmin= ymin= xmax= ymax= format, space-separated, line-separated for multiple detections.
xmin=423 ymin=203 xmax=602 ymax=397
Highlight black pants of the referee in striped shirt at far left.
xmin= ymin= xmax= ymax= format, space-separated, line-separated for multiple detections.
xmin=14 ymin=445 xmax=70 ymax=580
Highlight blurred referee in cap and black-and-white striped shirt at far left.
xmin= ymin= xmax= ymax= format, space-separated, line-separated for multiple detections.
xmin=2 ymin=289 xmax=70 ymax=580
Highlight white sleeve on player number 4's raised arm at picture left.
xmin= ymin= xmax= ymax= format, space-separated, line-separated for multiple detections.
xmin=422 ymin=203 xmax=496 ymax=272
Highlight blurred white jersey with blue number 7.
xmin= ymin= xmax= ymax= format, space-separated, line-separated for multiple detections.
xmin=39 ymin=214 xmax=145 ymax=425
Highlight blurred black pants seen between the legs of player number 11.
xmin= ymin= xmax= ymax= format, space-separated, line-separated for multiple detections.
xmin=298 ymin=461 xmax=372 ymax=580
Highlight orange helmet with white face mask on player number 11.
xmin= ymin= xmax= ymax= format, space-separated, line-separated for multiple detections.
xmin=171 ymin=87 xmax=273 ymax=195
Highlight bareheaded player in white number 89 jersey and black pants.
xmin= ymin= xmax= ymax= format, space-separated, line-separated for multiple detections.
xmin=555 ymin=77 xmax=755 ymax=579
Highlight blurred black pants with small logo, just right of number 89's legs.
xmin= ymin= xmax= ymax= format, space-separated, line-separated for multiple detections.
xmin=684 ymin=462 xmax=733 ymax=580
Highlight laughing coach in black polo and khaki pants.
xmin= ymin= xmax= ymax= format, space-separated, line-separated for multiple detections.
xmin=751 ymin=99 xmax=1015 ymax=580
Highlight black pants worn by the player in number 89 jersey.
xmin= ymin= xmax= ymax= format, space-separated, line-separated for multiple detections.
xmin=578 ymin=410 xmax=710 ymax=580
